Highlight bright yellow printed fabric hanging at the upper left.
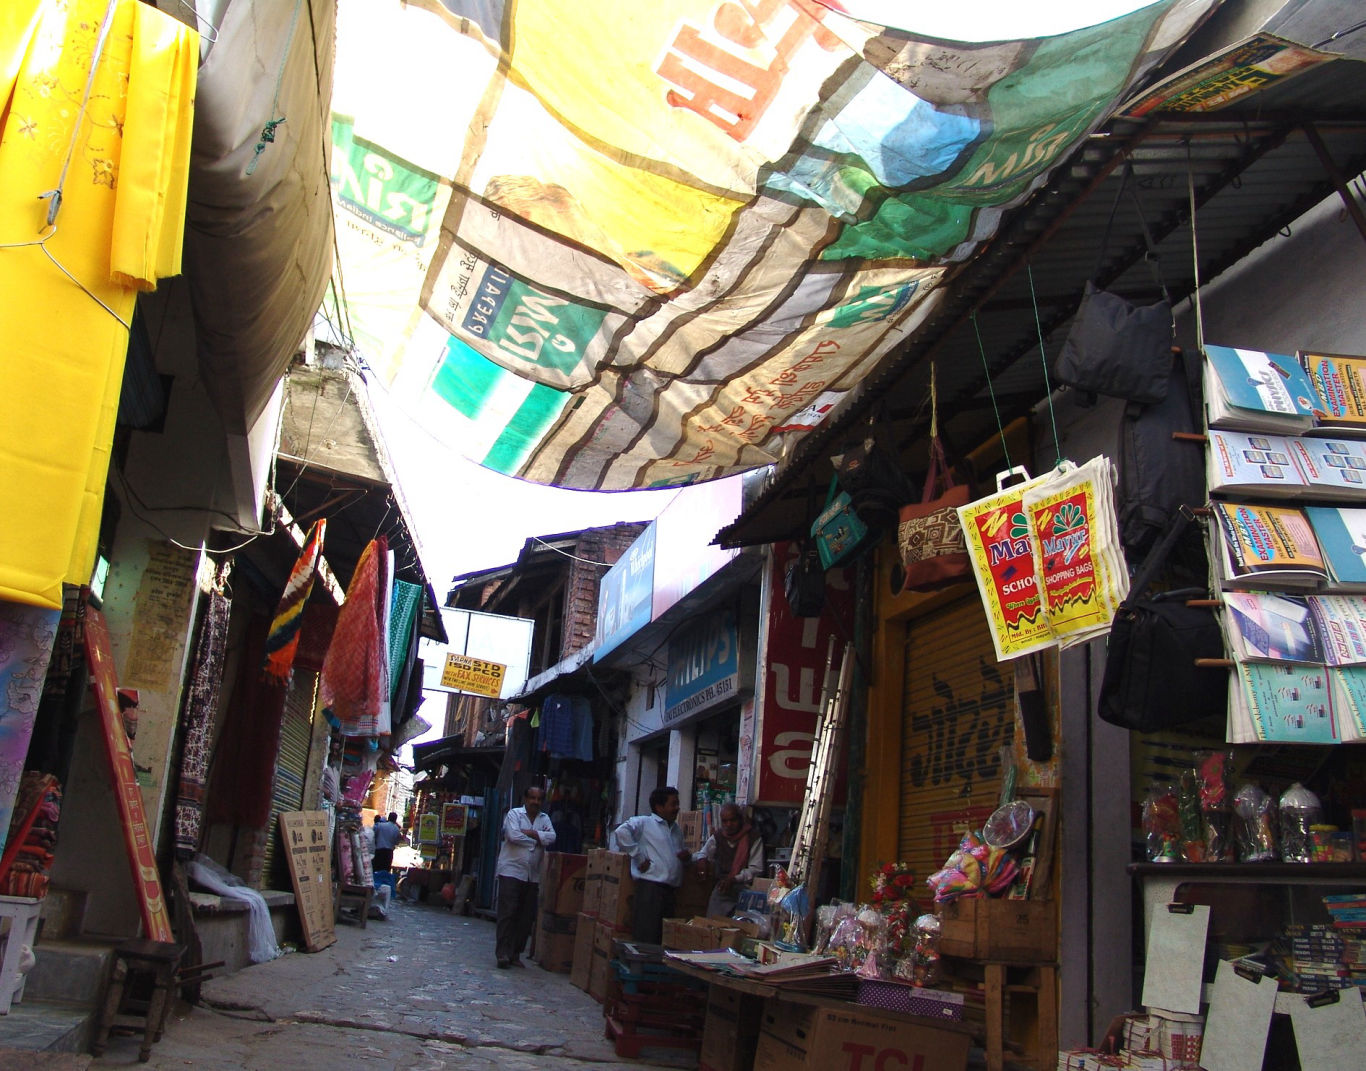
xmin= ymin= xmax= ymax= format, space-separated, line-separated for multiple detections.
xmin=0 ymin=0 xmax=198 ymax=608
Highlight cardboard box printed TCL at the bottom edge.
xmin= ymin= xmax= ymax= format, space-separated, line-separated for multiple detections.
xmin=754 ymin=1000 xmax=971 ymax=1071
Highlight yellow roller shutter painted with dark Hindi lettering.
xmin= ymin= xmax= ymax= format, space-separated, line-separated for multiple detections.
xmin=897 ymin=593 xmax=1015 ymax=895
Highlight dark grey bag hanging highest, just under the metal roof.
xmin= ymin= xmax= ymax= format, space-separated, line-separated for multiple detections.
xmin=1053 ymin=161 xmax=1175 ymax=406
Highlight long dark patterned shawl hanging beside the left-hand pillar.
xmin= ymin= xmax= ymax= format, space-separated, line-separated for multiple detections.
xmin=175 ymin=592 xmax=232 ymax=859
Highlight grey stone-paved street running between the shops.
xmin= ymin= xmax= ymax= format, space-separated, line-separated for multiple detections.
xmin=92 ymin=903 xmax=695 ymax=1071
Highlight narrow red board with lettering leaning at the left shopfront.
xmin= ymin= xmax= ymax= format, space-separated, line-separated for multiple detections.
xmin=86 ymin=607 xmax=175 ymax=941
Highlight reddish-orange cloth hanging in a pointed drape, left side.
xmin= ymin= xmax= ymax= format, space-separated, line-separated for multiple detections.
xmin=321 ymin=536 xmax=389 ymax=736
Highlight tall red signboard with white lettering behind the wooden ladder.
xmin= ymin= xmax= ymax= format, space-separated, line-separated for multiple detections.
xmin=753 ymin=542 xmax=854 ymax=806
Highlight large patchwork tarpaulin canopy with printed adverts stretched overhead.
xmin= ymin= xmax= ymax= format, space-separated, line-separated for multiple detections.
xmin=332 ymin=0 xmax=1214 ymax=490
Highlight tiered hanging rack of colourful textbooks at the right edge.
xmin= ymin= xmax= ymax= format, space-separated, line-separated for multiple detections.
xmin=1203 ymin=346 xmax=1366 ymax=743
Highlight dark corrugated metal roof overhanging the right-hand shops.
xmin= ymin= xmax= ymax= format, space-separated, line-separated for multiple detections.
xmin=716 ymin=44 xmax=1366 ymax=546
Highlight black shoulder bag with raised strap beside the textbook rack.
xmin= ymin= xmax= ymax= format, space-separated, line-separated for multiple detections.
xmin=1097 ymin=507 xmax=1228 ymax=732
